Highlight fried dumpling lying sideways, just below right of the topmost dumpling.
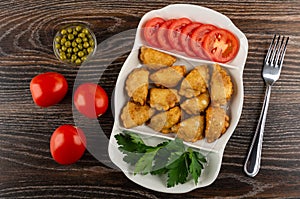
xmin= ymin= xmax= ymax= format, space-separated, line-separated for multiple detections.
xmin=150 ymin=66 xmax=186 ymax=88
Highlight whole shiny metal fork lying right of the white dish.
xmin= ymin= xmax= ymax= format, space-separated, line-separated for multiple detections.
xmin=244 ymin=35 xmax=289 ymax=177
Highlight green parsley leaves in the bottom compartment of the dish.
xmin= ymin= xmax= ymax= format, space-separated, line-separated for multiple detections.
xmin=115 ymin=131 xmax=206 ymax=187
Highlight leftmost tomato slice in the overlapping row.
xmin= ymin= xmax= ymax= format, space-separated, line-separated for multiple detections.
xmin=143 ymin=17 xmax=165 ymax=47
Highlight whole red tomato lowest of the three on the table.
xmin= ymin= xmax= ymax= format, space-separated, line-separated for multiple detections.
xmin=50 ymin=125 xmax=86 ymax=165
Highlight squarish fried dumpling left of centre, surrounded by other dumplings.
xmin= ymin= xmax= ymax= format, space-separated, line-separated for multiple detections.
xmin=149 ymin=88 xmax=180 ymax=111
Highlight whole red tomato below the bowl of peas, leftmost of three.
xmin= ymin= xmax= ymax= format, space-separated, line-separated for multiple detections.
xmin=30 ymin=72 xmax=68 ymax=107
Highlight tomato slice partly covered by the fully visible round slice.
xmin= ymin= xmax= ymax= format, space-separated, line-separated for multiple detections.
xmin=190 ymin=24 xmax=217 ymax=59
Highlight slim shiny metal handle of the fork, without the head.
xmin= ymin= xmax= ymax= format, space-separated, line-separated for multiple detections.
xmin=244 ymin=84 xmax=271 ymax=177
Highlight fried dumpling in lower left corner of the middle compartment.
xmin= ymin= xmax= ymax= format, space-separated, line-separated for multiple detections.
xmin=121 ymin=102 xmax=154 ymax=128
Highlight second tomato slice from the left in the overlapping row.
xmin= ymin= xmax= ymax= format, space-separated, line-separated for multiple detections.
xmin=156 ymin=19 xmax=176 ymax=50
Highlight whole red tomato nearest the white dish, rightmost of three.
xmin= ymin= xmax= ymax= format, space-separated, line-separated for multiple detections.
xmin=74 ymin=83 xmax=108 ymax=119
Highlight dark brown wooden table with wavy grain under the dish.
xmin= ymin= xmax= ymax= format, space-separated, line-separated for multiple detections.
xmin=0 ymin=0 xmax=300 ymax=198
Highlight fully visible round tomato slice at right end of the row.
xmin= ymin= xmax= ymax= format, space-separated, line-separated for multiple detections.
xmin=203 ymin=29 xmax=240 ymax=63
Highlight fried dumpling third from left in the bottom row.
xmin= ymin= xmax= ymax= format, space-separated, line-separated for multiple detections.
xmin=172 ymin=115 xmax=204 ymax=142
